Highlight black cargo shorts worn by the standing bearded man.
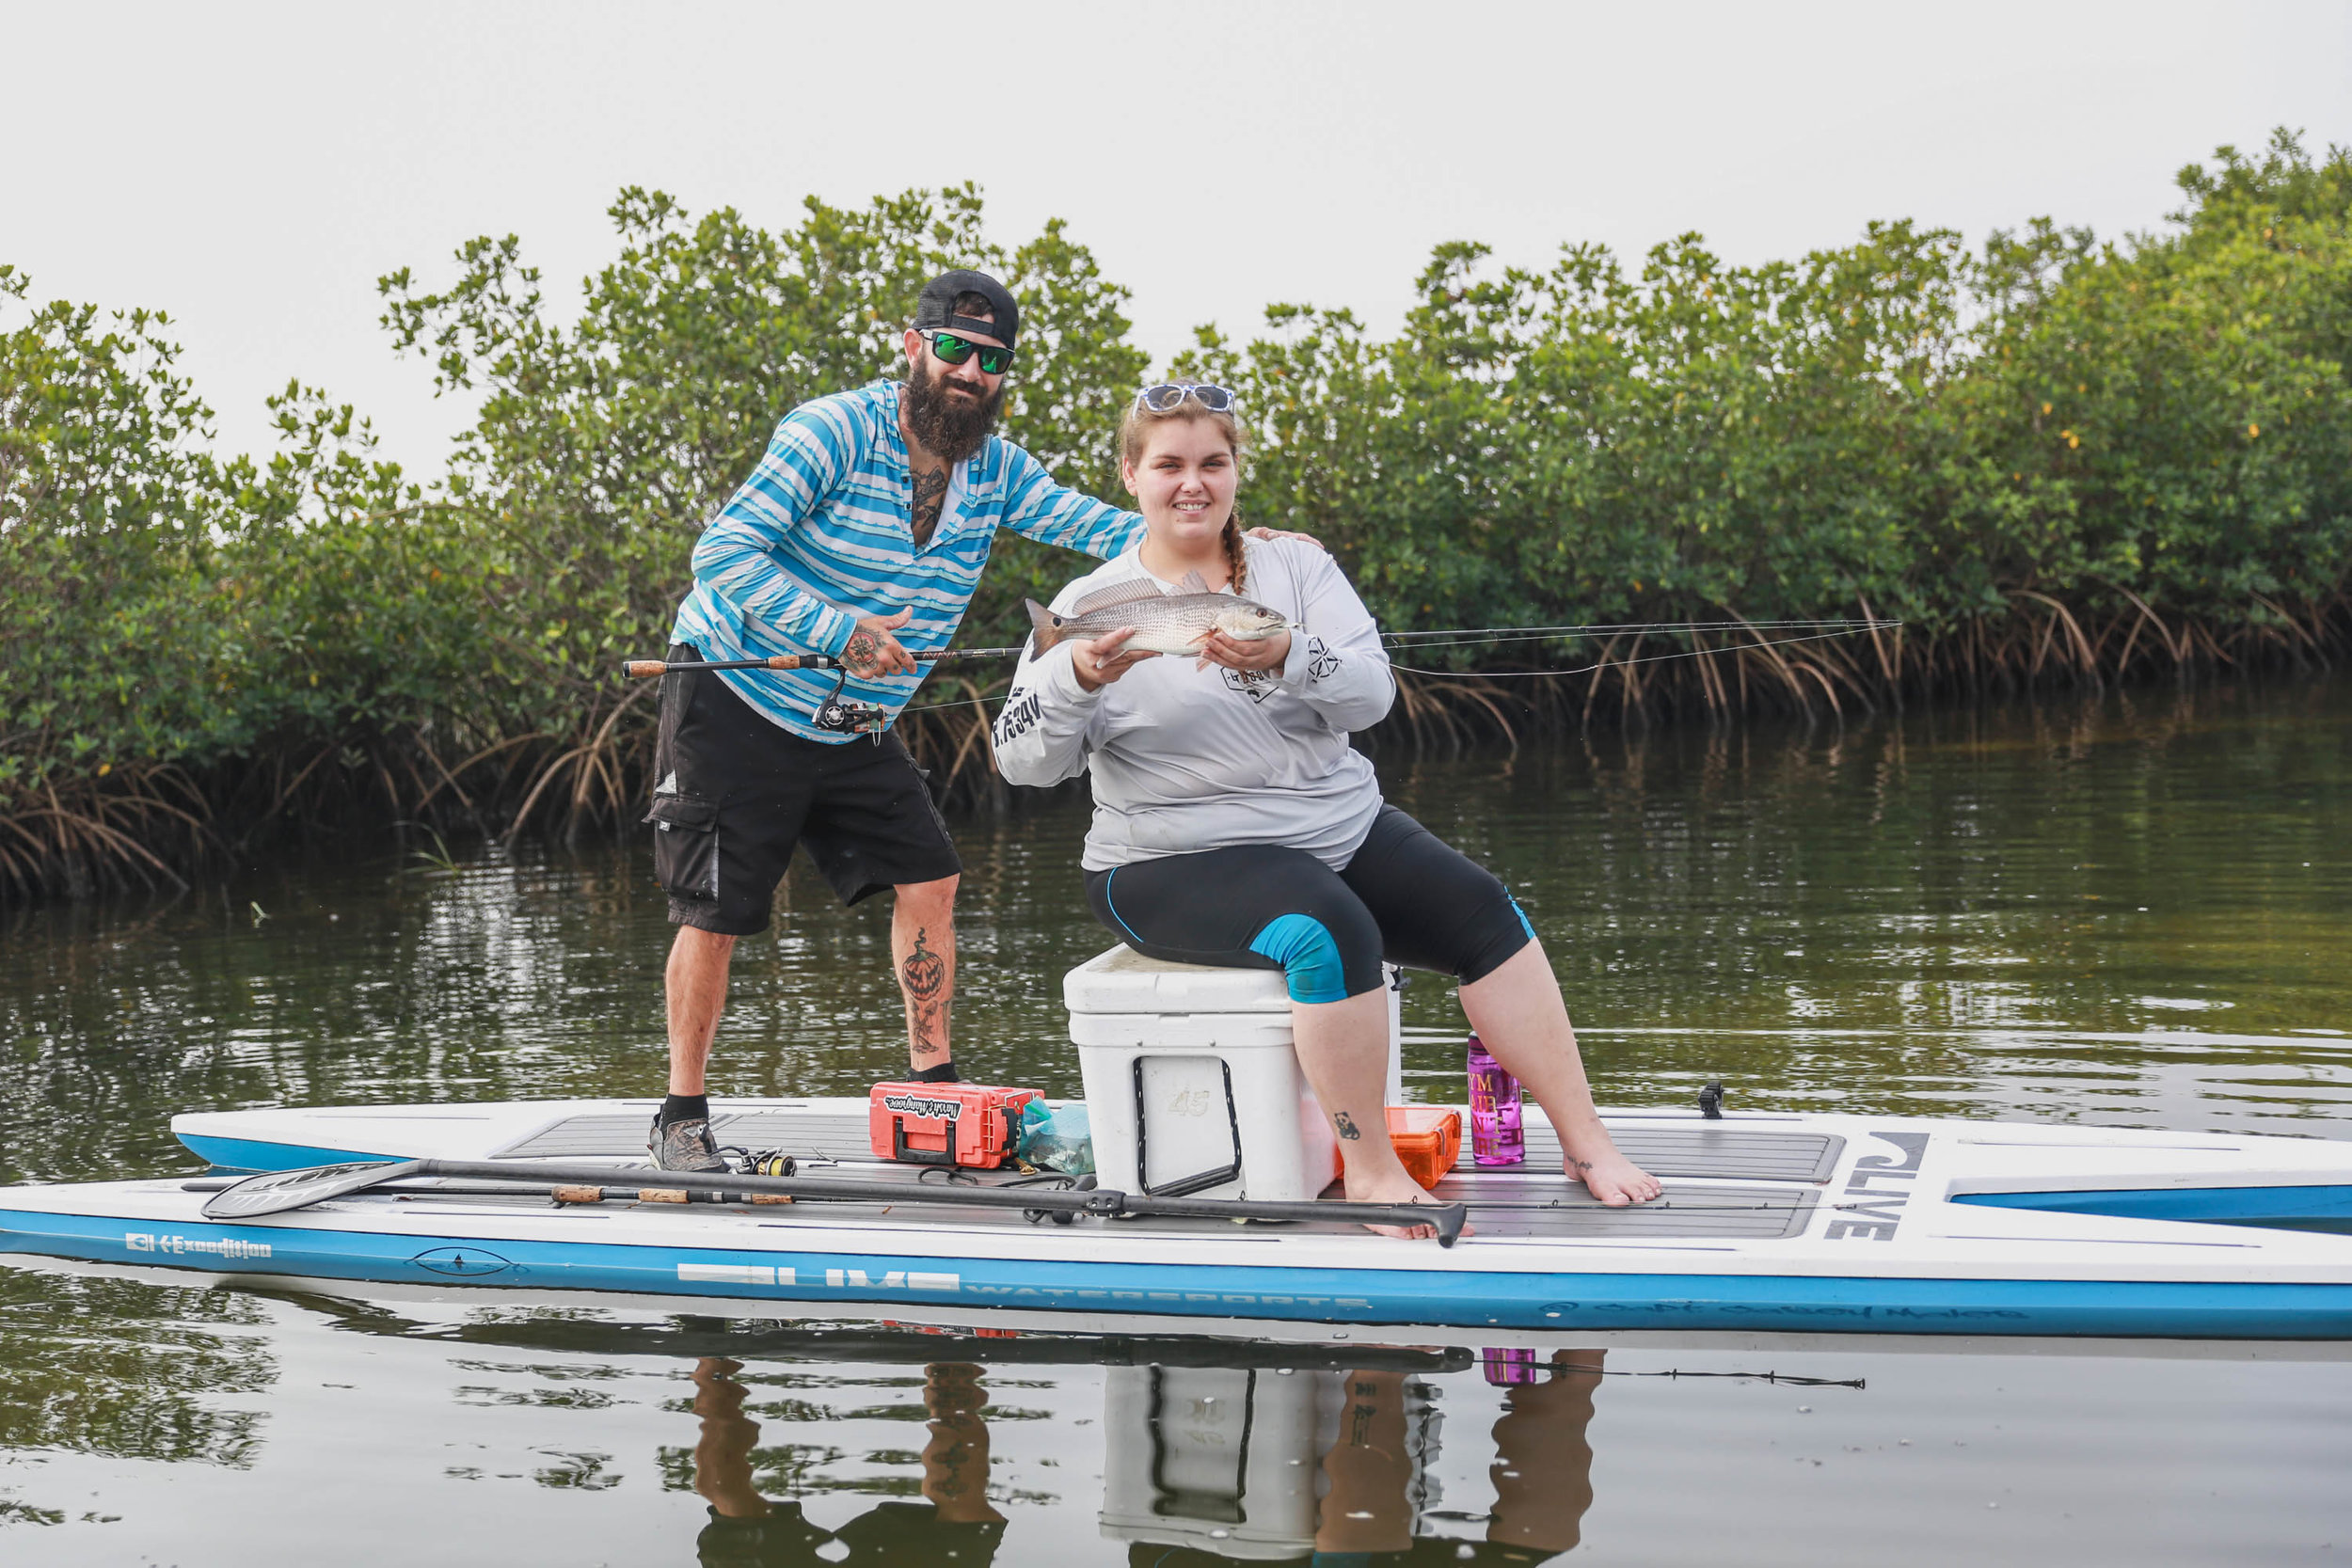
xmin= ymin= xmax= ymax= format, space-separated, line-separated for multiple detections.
xmin=644 ymin=644 xmax=964 ymax=936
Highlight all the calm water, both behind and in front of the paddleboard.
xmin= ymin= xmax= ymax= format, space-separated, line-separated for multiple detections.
xmin=0 ymin=682 xmax=2352 ymax=1568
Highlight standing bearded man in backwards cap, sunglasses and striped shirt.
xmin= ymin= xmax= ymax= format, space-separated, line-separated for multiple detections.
xmin=647 ymin=270 xmax=1279 ymax=1171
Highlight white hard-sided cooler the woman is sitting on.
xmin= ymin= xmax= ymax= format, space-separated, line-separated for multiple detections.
xmin=1061 ymin=947 xmax=1405 ymax=1201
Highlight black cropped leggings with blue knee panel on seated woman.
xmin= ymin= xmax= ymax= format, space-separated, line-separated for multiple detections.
xmin=1087 ymin=806 xmax=1536 ymax=1002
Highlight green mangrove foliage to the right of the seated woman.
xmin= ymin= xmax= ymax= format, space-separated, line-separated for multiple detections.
xmin=1181 ymin=134 xmax=2352 ymax=635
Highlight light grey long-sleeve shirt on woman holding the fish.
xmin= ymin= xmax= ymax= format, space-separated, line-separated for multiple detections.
xmin=995 ymin=538 xmax=1397 ymax=870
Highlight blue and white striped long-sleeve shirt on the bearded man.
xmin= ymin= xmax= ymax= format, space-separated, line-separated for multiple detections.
xmin=671 ymin=381 xmax=1143 ymax=740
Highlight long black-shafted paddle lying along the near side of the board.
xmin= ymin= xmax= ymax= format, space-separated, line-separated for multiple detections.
xmin=202 ymin=1159 xmax=1470 ymax=1246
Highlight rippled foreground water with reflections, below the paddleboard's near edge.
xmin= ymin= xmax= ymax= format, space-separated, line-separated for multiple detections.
xmin=0 ymin=1270 xmax=2352 ymax=1568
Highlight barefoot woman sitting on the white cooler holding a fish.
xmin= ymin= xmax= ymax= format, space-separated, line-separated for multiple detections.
xmin=995 ymin=383 xmax=1659 ymax=1234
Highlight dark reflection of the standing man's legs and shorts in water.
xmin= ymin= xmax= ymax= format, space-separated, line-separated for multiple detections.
xmin=694 ymin=1356 xmax=1005 ymax=1568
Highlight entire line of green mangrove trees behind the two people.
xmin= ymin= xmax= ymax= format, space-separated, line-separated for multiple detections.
xmin=0 ymin=144 xmax=2352 ymax=895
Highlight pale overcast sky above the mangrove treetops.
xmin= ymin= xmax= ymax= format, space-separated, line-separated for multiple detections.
xmin=0 ymin=0 xmax=2352 ymax=472
